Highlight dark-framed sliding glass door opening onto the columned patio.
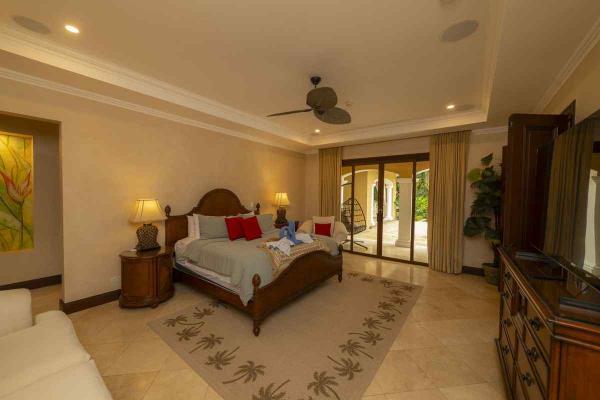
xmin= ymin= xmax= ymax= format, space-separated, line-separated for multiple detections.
xmin=341 ymin=154 xmax=429 ymax=264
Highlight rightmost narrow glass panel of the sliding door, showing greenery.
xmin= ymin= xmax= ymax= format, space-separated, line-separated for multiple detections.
xmin=413 ymin=161 xmax=429 ymax=263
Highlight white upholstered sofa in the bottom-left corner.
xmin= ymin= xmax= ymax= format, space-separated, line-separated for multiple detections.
xmin=0 ymin=289 xmax=112 ymax=400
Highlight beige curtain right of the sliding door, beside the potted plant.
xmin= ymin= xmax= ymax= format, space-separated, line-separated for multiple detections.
xmin=427 ymin=131 xmax=470 ymax=274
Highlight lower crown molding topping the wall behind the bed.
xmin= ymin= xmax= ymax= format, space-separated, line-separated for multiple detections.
xmin=0 ymin=67 xmax=306 ymax=153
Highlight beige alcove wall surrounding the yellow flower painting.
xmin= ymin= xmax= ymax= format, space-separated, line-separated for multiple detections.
xmin=0 ymin=114 xmax=62 ymax=286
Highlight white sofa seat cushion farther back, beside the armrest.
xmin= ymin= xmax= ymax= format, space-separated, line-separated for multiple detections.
xmin=0 ymin=312 xmax=90 ymax=397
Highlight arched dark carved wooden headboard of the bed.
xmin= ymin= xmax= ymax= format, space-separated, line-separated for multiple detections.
xmin=165 ymin=189 xmax=260 ymax=247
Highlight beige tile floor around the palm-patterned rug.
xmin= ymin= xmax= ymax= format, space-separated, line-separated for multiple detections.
xmin=32 ymin=254 xmax=505 ymax=400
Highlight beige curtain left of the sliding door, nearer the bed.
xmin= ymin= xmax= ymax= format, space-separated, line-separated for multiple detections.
xmin=319 ymin=147 xmax=342 ymax=221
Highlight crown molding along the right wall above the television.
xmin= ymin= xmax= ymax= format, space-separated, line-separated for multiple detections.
xmin=535 ymin=18 xmax=600 ymax=113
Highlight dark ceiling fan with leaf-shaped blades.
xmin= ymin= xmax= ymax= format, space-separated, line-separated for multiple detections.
xmin=267 ymin=76 xmax=352 ymax=124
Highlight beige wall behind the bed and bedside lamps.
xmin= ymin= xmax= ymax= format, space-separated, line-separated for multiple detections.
xmin=0 ymin=80 xmax=305 ymax=301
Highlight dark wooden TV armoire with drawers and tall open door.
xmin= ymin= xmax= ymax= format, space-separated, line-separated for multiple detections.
xmin=496 ymin=114 xmax=600 ymax=400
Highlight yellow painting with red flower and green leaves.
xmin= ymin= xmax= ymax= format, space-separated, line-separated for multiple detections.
xmin=0 ymin=132 xmax=33 ymax=252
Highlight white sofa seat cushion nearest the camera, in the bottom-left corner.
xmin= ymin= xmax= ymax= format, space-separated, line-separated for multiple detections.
xmin=1 ymin=360 xmax=112 ymax=400
